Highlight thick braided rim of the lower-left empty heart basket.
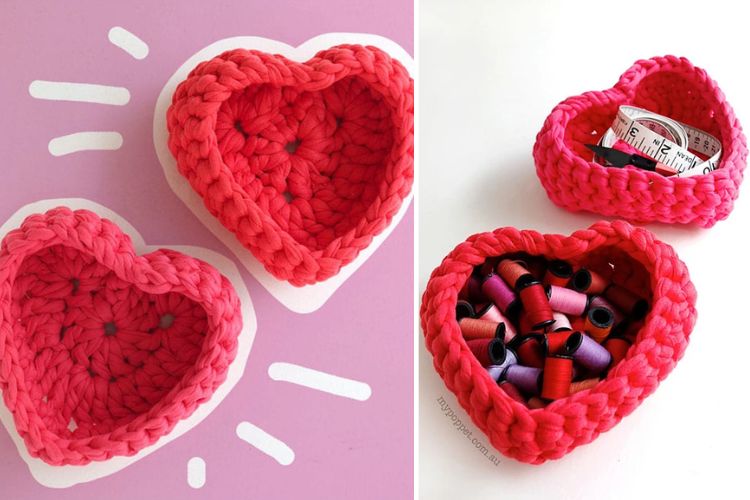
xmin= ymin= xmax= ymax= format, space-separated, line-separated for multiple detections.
xmin=0 ymin=207 xmax=242 ymax=465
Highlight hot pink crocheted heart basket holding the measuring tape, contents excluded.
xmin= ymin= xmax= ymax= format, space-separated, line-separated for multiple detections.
xmin=534 ymin=56 xmax=747 ymax=227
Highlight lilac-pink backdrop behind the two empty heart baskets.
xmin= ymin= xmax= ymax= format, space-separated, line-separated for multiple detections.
xmin=0 ymin=0 xmax=413 ymax=500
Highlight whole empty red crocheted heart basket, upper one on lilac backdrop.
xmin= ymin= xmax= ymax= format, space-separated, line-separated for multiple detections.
xmin=167 ymin=45 xmax=414 ymax=286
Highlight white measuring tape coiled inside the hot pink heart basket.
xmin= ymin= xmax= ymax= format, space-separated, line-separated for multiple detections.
xmin=599 ymin=106 xmax=721 ymax=177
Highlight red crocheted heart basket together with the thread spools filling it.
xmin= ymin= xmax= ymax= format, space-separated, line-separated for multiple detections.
xmin=421 ymin=222 xmax=695 ymax=464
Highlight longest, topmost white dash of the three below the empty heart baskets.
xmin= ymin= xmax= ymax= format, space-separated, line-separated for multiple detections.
xmin=268 ymin=363 xmax=372 ymax=401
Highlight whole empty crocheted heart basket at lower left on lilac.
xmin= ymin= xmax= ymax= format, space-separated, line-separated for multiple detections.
xmin=0 ymin=208 xmax=242 ymax=465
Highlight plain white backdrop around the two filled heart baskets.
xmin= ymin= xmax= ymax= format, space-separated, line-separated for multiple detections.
xmin=418 ymin=0 xmax=750 ymax=500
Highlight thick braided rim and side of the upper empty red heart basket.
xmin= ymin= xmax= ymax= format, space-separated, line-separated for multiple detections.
xmin=167 ymin=44 xmax=414 ymax=286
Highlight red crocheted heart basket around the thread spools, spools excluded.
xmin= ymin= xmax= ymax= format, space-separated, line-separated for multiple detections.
xmin=421 ymin=221 xmax=696 ymax=464
